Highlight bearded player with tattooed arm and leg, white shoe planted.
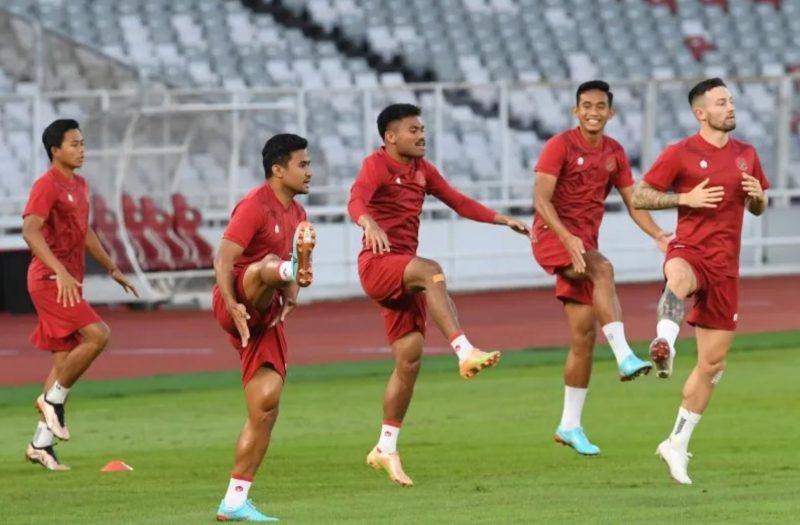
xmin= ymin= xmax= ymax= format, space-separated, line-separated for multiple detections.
xmin=633 ymin=78 xmax=769 ymax=484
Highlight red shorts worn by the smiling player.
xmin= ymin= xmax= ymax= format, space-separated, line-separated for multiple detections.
xmin=531 ymin=228 xmax=597 ymax=306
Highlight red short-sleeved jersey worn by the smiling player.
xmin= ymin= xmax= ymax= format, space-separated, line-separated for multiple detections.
xmin=533 ymin=128 xmax=633 ymax=239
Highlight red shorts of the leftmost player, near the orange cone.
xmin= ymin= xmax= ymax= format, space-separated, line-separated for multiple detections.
xmin=28 ymin=281 xmax=102 ymax=352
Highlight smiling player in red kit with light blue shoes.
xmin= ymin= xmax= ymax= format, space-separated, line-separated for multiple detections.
xmin=531 ymin=80 xmax=670 ymax=456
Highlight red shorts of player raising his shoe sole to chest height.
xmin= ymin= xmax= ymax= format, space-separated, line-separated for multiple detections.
xmin=212 ymin=270 xmax=287 ymax=385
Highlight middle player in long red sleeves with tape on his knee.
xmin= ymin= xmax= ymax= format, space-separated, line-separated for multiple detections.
xmin=348 ymin=104 xmax=529 ymax=486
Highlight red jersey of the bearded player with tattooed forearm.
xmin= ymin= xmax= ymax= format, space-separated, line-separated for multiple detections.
xmin=644 ymin=134 xmax=769 ymax=277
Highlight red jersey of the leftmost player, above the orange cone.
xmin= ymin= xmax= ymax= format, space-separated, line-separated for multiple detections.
xmin=22 ymin=167 xmax=89 ymax=288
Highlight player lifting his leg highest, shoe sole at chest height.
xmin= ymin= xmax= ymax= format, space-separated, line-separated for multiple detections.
xmin=213 ymin=133 xmax=316 ymax=521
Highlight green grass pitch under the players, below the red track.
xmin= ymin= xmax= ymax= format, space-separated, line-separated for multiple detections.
xmin=0 ymin=332 xmax=800 ymax=525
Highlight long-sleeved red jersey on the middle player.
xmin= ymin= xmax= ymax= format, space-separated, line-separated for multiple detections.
xmin=347 ymin=147 xmax=497 ymax=255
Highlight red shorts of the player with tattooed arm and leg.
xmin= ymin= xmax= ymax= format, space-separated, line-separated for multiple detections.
xmin=664 ymin=247 xmax=739 ymax=331
